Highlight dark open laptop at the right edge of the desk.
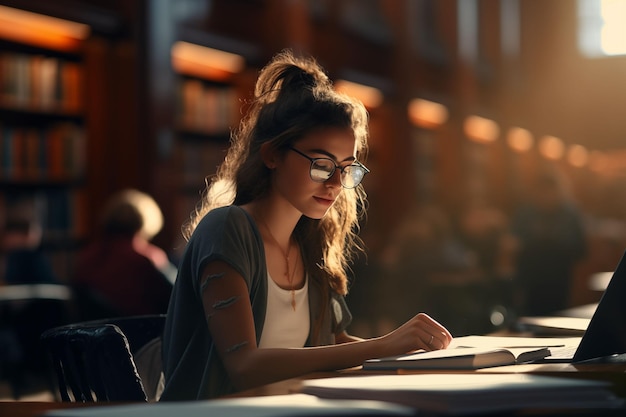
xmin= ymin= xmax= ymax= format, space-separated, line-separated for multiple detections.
xmin=539 ymin=252 xmax=626 ymax=363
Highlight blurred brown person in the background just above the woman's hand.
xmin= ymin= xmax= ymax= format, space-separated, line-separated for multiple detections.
xmin=379 ymin=202 xmax=475 ymax=333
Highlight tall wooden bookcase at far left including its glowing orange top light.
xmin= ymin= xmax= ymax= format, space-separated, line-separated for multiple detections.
xmin=0 ymin=1 xmax=124 ymax=282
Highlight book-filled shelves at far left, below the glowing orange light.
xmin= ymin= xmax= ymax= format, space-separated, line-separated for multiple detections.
xmin=0 ymin=8 xmax=88 ymax=281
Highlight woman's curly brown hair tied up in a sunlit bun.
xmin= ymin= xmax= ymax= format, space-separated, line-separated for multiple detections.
xmin=183 ymin=50 xmax=368 ymax=294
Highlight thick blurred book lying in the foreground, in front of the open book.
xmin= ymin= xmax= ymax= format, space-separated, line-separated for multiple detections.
xmin=300 ymin=373 xmax=624 ymax=415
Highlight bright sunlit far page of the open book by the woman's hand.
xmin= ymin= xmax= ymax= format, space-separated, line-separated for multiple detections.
xmin=448 ymin=336 xmax=581 ymax=349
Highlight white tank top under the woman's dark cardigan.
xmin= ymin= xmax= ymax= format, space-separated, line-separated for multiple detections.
xmin=259 ymin=273 xmax=310 ymax=348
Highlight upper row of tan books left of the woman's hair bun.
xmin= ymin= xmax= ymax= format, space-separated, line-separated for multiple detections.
xmin=177 ymin=79 xmax=240 ymax=135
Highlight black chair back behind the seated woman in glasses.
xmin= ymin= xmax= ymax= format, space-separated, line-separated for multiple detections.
xmin=41 ymin=315 xmax=165 ymax=402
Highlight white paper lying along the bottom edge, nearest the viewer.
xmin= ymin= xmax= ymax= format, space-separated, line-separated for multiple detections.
xmin=44 ymin=394 xmax=415 ymax=417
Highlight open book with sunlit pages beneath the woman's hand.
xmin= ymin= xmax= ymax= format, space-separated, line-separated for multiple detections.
xmin=363 ymin=336 xmax=579 ymax=370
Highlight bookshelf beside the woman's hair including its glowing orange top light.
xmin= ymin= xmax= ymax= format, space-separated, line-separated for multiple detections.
xmin=172 ymin=42 xmax=252 ymax=242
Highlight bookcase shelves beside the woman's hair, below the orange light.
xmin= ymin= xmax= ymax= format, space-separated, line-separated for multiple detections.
xmin=169 ymin=38 xmax=254 ymax=254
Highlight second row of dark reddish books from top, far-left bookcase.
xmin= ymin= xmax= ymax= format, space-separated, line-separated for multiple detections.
xmin=0 ymin=122 xmax=86 ymax=182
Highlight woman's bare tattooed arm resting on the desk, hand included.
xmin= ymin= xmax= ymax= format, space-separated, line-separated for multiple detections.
xmin=202 ymin=262 xmax=452 ymax=390
